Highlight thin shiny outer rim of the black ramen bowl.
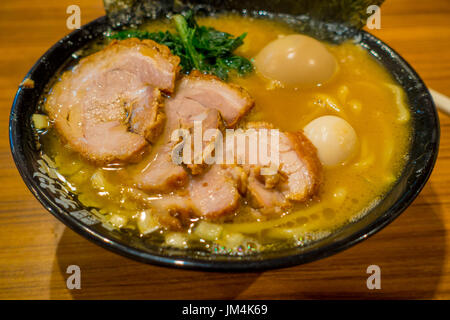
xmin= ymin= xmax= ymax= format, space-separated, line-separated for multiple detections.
xmin=9 ymin=16 xmax=440 ymax=272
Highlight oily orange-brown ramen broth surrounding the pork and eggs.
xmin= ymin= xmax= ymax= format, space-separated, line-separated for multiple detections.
xmin=37 ymin=15 xmax=410 ymax=254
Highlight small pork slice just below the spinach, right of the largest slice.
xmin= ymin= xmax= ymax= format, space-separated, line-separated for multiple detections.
xmin=177 ymin=71 xmax=254 ymax=128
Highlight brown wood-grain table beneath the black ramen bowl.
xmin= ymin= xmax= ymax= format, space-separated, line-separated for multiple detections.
xmin=0 ymin=0 xmax=450 ymax=299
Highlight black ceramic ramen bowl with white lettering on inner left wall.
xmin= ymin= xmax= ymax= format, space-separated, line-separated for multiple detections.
xmin=9 ymin=8 xmax=439 ymax=271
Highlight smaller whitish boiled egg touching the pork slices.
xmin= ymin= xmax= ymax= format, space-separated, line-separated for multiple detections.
xmin=303 ymin=116 xmax=358 ymax=166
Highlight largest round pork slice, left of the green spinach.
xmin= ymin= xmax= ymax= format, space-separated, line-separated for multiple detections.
xmin=45 ymin=39 xmax=179 ymax=163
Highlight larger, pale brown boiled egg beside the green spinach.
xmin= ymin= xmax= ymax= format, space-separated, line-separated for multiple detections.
xmin=254 ymin=34 xmax=336 ymax=86
